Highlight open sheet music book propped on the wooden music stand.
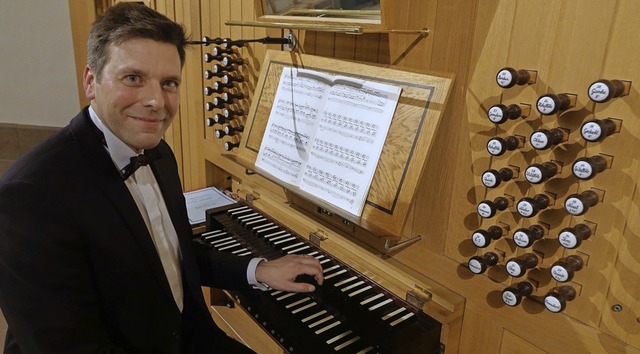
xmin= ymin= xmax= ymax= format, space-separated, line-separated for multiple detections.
xmin=256 ymin=67 xmax=402 ymax=217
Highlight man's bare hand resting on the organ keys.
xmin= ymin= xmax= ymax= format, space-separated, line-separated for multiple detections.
xmin=256 ymin=254 xmax=324 ymax=292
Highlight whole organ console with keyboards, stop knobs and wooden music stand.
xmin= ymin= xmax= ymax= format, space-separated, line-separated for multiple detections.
xmin=150 ymin=0 xmax=640 ymax=354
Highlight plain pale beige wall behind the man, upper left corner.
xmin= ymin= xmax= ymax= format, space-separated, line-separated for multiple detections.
xmin=0 ymin=0 xmax=80 ymax=127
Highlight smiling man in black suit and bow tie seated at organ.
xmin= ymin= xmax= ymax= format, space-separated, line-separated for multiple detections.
xmin=0 ymin=3 xmax=323 ymax=354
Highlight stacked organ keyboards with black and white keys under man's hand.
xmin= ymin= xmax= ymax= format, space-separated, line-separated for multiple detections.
xmin=200 ymin=202 xmax=441 ymax=354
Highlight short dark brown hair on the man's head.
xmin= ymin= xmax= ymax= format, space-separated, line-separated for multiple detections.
xmin=87 ymin=2 xmax=187 ymax=80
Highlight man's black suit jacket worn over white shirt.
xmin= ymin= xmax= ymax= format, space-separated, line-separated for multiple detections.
xmin=0 ymin=108 xmax=255 ymax=354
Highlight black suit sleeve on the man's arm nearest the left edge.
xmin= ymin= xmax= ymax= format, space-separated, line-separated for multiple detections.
xmin=0 ymin=181 xmax=125 ymax=354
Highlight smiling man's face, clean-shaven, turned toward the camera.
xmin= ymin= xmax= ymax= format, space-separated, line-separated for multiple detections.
xmin=84 ymin=38 xmax=181 ymax=151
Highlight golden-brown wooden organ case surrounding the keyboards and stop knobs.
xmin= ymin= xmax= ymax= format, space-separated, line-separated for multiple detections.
xmin=70 ymin=0 xmax=640 ymax=354
